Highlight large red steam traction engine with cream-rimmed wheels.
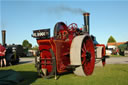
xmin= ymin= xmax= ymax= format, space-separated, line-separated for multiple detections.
xmin=32 ymin=13 xmax=106 ymax=78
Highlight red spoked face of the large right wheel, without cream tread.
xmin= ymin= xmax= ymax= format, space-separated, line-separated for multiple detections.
xmin=81 ymin=37 xmax=95 ymax=76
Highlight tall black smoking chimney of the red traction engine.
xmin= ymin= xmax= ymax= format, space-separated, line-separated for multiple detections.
xmin=83 ymin=13 xmax=90 ymax=34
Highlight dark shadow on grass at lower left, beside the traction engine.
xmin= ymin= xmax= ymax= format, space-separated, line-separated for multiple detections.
xmin=17 ymin=71 xmax=38 ymax=85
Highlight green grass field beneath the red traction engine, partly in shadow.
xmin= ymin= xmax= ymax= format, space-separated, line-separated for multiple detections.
xmin=1 ymin=64 xmax=128 ymax=85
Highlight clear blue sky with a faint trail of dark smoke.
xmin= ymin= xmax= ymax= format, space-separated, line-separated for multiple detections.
xmin=0 ymin=0 xmax=128 ymax=46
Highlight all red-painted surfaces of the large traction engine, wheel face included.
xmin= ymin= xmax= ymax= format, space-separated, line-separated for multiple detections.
xmin=37 ymin=22 xmax=105 ymax=75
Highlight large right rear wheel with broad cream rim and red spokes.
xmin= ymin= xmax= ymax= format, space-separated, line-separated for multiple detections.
xmin=70 ymin=34 xmax=95 ymax=76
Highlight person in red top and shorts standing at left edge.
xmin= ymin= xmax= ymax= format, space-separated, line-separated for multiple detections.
xmin=0 ymin=43 xmax=6 ymax=67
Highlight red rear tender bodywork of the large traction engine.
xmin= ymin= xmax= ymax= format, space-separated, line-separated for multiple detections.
xmin=37 ymin=38 xmax=70 ymax=73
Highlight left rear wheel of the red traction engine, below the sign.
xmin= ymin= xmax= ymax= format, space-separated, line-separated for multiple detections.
xmin=36 ymin=49 xmax=56 ymax=78
